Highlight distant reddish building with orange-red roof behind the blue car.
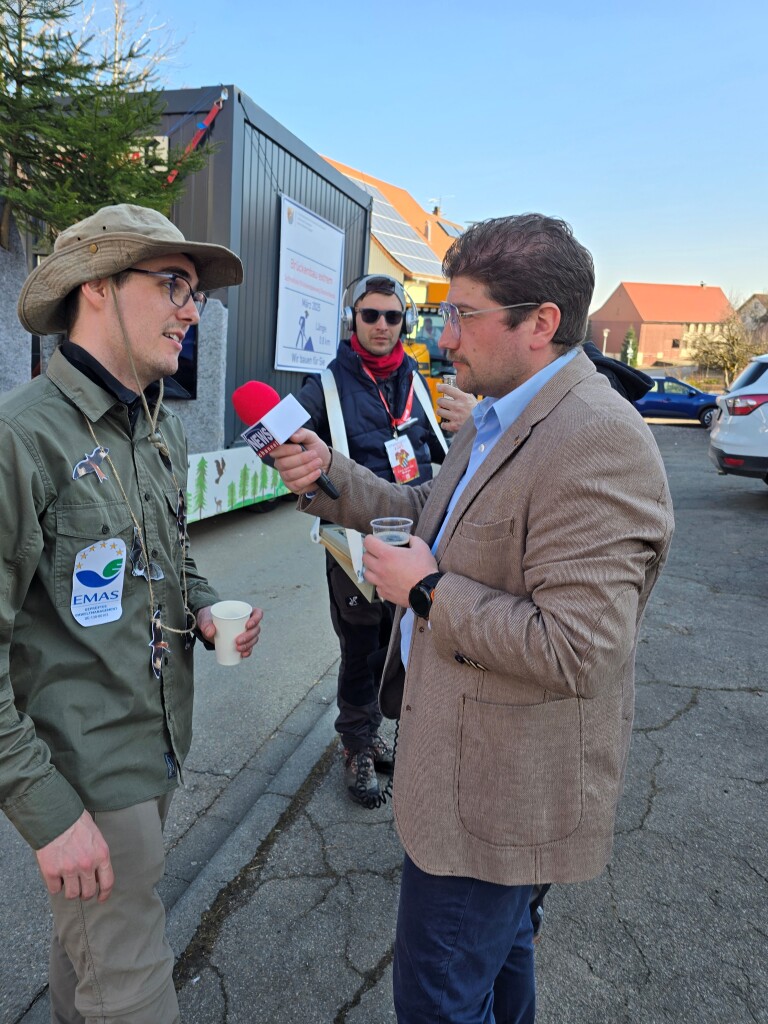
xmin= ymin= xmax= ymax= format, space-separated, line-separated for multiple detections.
xmin=590 ymin=281 xmax=732 ymax=368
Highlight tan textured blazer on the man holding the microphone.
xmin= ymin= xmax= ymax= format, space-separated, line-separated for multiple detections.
xmin=302 ymin=354 xmax=674 ymax=885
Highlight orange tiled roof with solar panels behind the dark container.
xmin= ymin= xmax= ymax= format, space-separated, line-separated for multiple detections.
xmin=324 ymin=157 xmax=464 ymax=278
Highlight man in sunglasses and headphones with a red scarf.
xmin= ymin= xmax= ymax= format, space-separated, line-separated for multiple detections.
xmin=298 ymin=274 xmax=471 ymax=807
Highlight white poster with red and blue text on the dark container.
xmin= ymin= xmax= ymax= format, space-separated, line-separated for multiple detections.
xmin=274 ymin=196 xmax=344 ymax=373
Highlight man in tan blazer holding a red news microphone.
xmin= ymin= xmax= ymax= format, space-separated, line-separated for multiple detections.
xmin=275 ymin=214 xmax=673 ymax=1024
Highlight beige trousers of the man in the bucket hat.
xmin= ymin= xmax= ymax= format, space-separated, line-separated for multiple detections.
xmin=49 ymin=795 xmax=180 ymax=1024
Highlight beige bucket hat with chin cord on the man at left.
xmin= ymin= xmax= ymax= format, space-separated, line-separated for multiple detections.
xmin=17 ymin=203 xmax=243 ymax=334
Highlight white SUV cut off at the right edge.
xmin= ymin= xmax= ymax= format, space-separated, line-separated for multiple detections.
xmin=710 ymin=354 xmax=768 ymax=483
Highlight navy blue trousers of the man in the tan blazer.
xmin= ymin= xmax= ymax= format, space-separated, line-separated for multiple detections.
xmin=393 ymin=854 xmax=536 ymax=1024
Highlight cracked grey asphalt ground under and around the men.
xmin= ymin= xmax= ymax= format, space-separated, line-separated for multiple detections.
xmin=0 ymin=425 xmax=768 ymax=1024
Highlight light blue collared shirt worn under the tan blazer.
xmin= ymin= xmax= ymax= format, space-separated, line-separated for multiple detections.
xmin=400 ymin=345 xmax=582 ymax=665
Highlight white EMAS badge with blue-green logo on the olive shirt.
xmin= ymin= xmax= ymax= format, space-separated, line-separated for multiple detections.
xmin=71 ymin=537 xmax=125 ymax=626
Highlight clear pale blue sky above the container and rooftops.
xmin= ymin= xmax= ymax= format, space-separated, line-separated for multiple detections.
xmin=88 ymin=0 xmax=768 ymax=308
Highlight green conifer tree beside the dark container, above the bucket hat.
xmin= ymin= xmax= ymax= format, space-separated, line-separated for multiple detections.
xmin=0 ymin=0 xmax=210 ymax=248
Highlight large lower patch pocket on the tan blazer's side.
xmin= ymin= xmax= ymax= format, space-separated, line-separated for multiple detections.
xmin=454 ymin=696 xmax=583 ymax=847
